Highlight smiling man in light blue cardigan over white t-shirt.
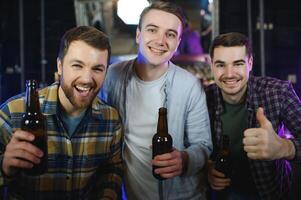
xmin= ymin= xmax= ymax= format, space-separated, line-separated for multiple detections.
xmin=102 ymin=1 xmax=212 ymax=200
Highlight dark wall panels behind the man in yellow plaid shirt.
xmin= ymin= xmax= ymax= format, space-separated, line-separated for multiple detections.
xmin=0 ymin=0 xmax=75 ymax=103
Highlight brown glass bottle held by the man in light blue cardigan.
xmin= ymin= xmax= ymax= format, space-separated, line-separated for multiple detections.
xmin=152 ymin=107 xmax=172 ymax=180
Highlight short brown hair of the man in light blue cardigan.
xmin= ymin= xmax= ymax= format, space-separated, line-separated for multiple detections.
xmin=138 ymin=1 xmax=186 ymax=33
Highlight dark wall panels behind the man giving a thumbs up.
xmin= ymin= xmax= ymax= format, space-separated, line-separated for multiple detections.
xmin=220 ymin=0 xmax=301 ymax=96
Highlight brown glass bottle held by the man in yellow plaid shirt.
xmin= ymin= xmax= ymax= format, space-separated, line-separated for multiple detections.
xmin=21 ymin=80 xmax=48 ymax=176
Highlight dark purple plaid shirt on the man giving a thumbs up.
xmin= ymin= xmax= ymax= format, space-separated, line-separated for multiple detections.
xmin=206 ymin=76 xmax=301 ymax=200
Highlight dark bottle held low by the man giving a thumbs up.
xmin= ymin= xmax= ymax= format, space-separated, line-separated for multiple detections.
xmin=215 ymin=135 xmax=231 ymax=178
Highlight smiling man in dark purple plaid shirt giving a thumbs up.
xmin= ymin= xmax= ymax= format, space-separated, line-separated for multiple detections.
xmin=206 ymin=33 xmax=301 ymax=200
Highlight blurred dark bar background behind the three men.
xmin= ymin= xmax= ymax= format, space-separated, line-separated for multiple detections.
xmin=0 ymin=0 xmax=301 ymax=196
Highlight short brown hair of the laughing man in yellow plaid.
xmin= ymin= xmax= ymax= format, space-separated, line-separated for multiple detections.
xmin=58 ymin=26 xmax=111 ymax=65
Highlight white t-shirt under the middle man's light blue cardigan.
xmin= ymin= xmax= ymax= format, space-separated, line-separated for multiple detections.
xmin=124 ymin=72 xmax=167 ymax=200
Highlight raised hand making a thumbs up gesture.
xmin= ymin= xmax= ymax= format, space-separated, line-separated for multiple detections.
xmin=243 ymin=107 xmax=295 ymax=160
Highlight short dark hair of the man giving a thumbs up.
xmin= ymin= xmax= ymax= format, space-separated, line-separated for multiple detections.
xmin=210 ymin=32 xmax=252 ymax=58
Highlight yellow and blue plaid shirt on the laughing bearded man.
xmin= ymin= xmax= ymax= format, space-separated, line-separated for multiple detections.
xmin=0 ymin=83 xmax=123 ymax=200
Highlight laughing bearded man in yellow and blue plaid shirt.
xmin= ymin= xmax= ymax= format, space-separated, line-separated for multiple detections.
xmin=0 ymin=26 xmax=123 ymax=200
